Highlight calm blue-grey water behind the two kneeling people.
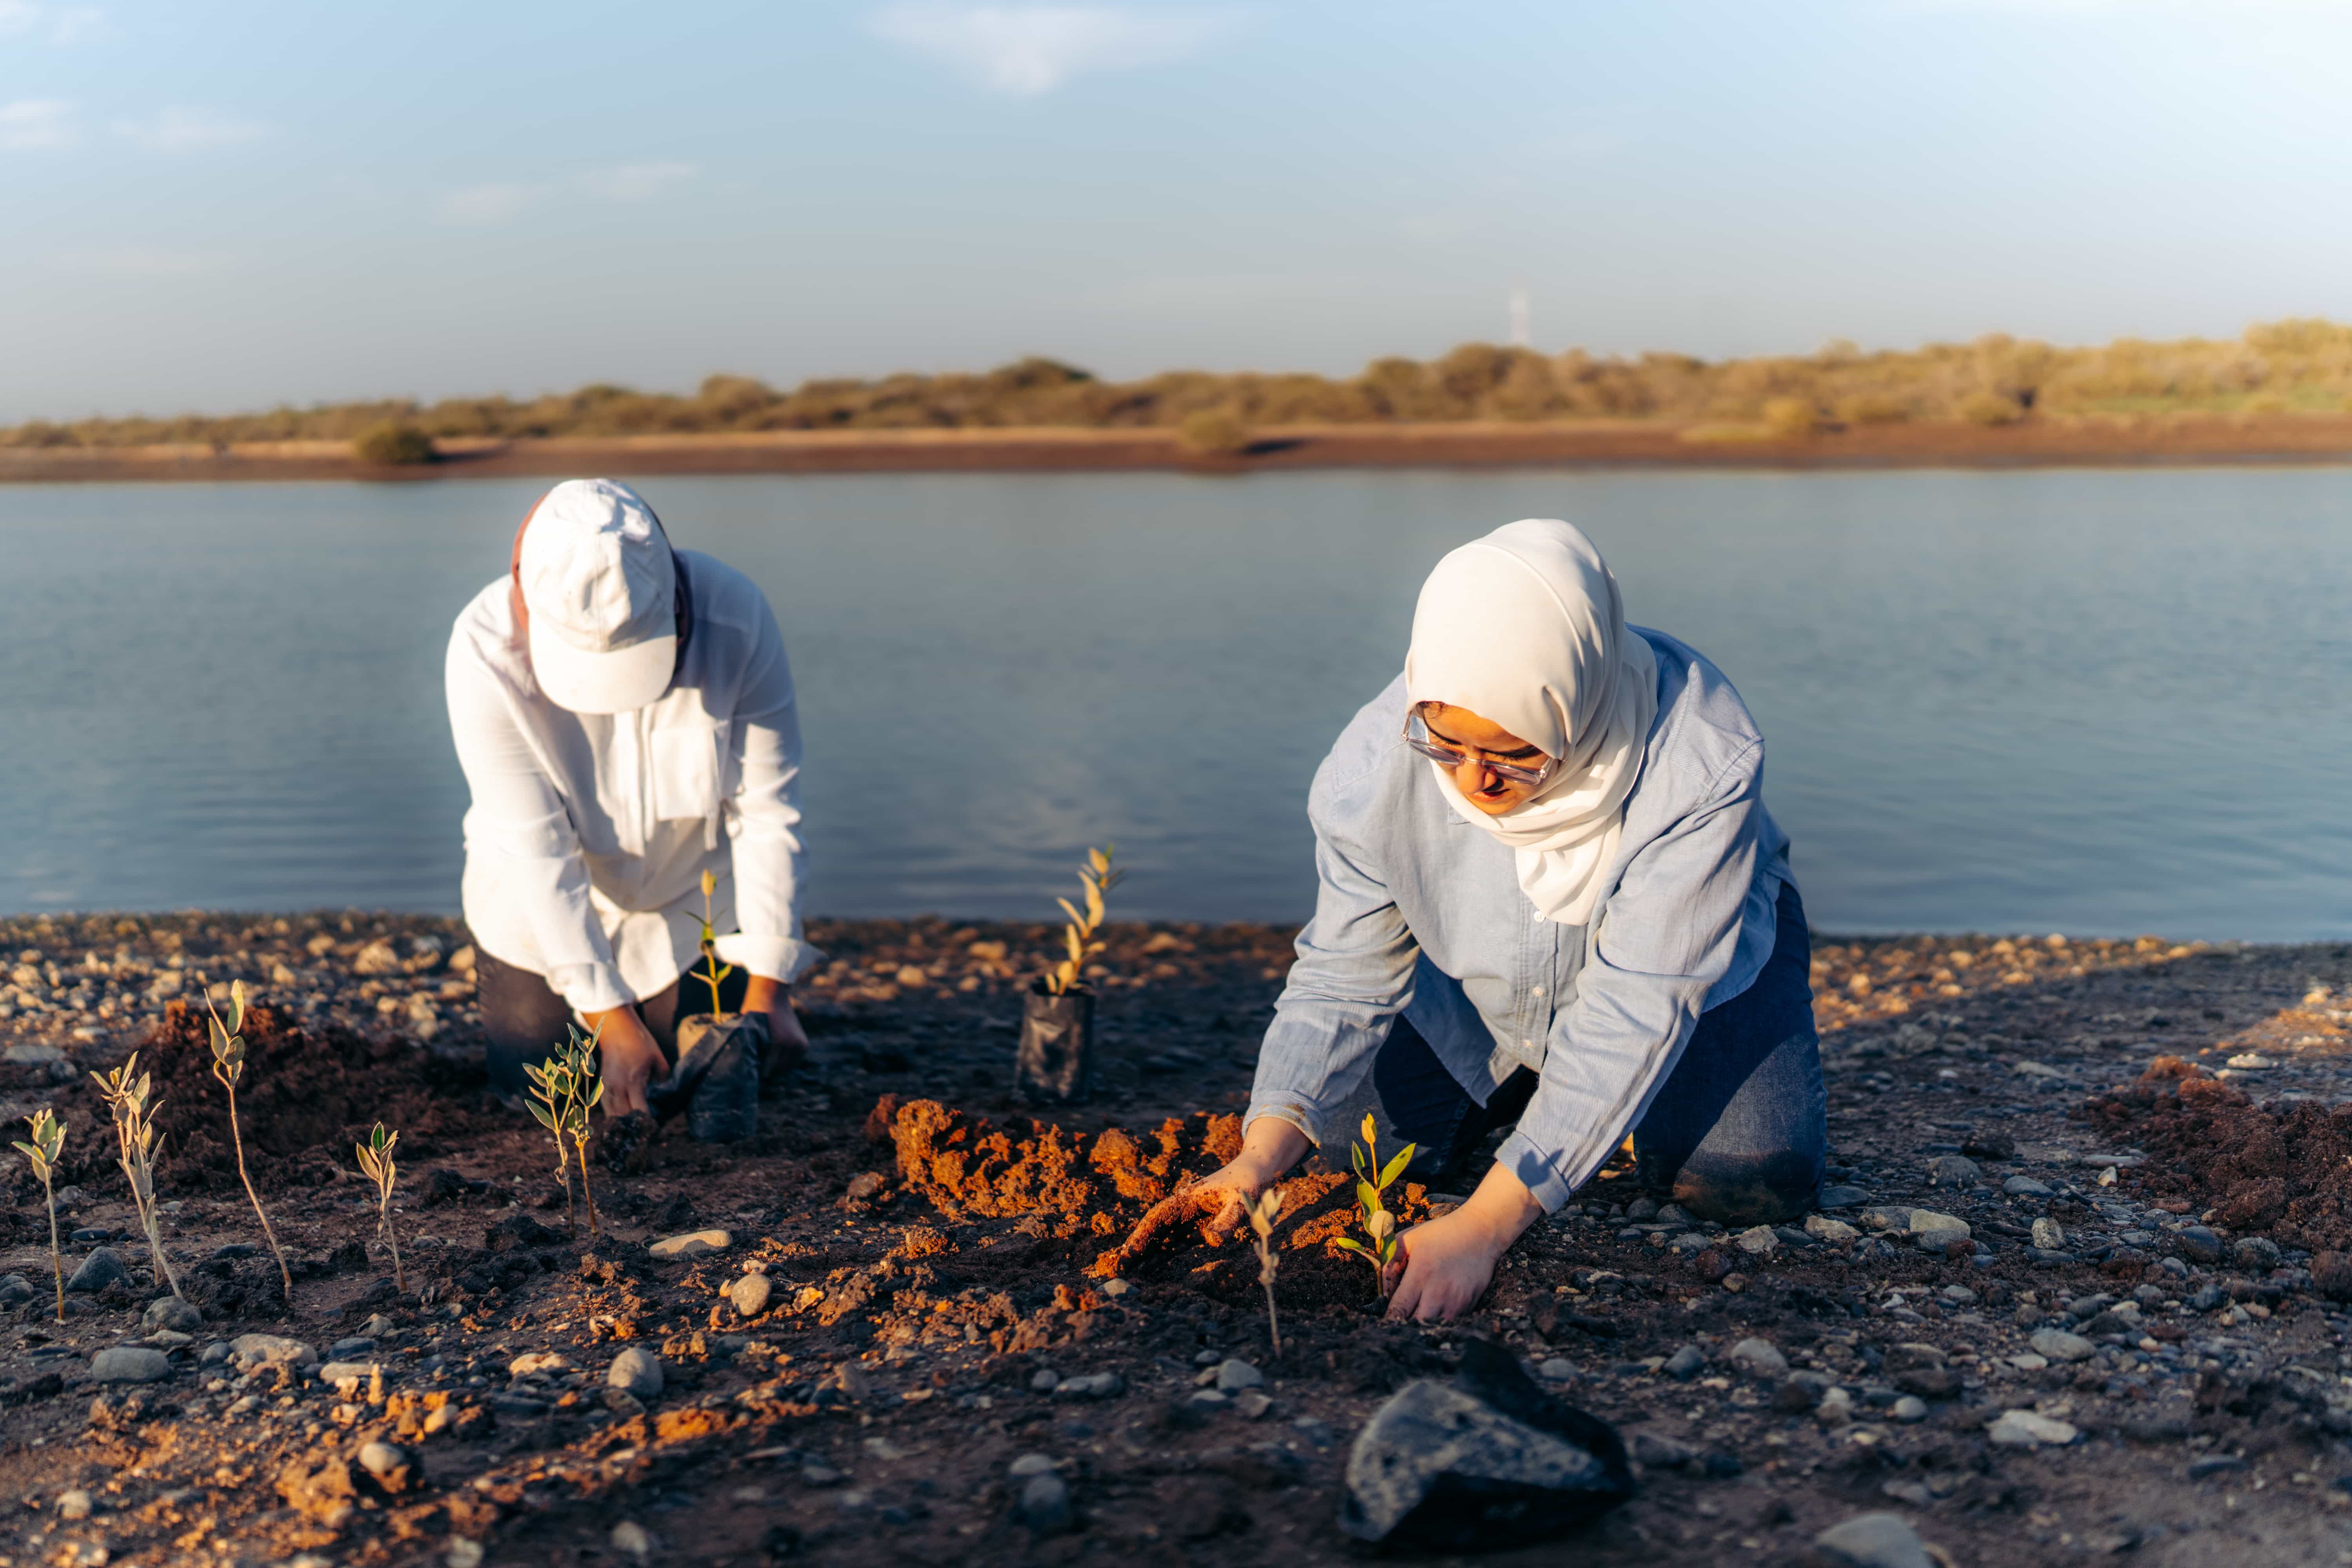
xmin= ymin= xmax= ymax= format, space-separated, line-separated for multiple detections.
xmin=0 ymin=470 xmax=2352 ymax=940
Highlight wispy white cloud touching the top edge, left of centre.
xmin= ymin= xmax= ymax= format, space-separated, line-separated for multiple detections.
xmin=873 ymin=5 xmax=1230 ymax=99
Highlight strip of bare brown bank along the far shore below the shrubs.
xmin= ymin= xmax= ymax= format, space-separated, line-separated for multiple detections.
xmin=14 ymin=414 xmax=2352 ymax=484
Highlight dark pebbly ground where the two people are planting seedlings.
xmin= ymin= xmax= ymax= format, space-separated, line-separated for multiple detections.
xmin=0 ymin=915 xmax=2352 ymax=1568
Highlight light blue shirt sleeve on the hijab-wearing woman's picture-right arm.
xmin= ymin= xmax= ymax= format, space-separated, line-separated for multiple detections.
xmin=1496 ymin=745 xmax=1764 ymax=1208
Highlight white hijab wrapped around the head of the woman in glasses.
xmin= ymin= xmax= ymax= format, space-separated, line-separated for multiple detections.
xmin=1404 ymin=517 xmax=1658 ymax=926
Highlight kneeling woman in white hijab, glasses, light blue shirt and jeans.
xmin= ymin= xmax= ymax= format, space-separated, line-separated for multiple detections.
xmin=1138 ymin=519 xmax=1828 ymax=1319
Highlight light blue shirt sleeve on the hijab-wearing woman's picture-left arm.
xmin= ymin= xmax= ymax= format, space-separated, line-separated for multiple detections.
xmin=1242 ymin=776 xmax=1421 ymax=1143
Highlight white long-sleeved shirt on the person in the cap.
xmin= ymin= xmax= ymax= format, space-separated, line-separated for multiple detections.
xmin=449 ymin=550 xmax=823 ymax=1013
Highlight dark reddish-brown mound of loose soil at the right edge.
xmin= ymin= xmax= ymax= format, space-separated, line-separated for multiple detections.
xmin=2082 ymin=1056 xmax=2352 ymax=1253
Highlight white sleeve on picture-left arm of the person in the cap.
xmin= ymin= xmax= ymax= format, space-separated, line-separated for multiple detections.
xmin=447 ymin=632 xmax=637 ymax=1013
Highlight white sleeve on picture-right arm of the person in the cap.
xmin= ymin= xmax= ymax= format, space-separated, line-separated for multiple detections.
xmin=717 ymin=599 xmax=818 ymax=980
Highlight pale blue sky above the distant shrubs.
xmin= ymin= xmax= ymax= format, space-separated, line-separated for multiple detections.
xmin=0 ymin=0 xmax=2352 ymax=418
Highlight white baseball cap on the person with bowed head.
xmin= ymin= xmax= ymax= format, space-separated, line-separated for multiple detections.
xmin=515 ymin=479 xmax=677 ymax=712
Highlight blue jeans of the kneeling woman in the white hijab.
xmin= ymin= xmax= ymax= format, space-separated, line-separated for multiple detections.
xmin=1371 ymin=882 xmax=1830 ymax=1225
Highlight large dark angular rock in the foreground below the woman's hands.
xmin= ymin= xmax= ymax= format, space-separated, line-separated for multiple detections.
xmin=1341 ymin=1340 xmax=1632 ymax=1552
